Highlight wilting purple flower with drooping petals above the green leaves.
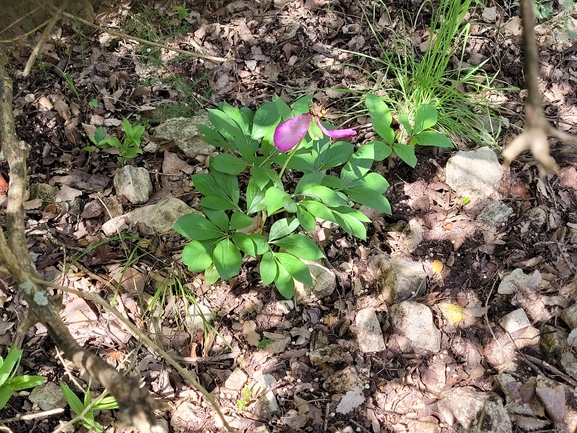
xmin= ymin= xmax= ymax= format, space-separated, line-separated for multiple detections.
xmin=273 ymin=103 xmax=357 ymax=152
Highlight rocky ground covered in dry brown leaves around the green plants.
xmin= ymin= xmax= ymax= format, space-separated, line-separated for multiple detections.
xmin=0 ymin=0 xmax=577 ymax=433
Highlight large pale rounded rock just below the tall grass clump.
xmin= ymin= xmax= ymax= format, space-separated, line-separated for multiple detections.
xmin=445 ymin=147 xmax=503 ymax=199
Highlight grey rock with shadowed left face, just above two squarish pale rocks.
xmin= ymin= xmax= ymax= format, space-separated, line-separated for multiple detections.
xmin=378 ymin=254 xmax=427 ymax=304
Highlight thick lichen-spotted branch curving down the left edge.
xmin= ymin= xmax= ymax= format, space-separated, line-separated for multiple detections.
xmin=0 ymin=53 xmax=165 ymax=433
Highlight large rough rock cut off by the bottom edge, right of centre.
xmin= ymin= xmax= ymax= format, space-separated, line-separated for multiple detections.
xmin=437 ymin=386 xmax=513 ymax=433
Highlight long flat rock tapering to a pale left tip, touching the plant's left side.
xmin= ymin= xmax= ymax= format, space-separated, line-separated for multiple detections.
xmin=102 ymin=196 xmax=199 ymax=236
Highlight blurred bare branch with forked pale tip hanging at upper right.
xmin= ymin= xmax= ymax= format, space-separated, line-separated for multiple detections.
xmin=503 ymin=0 xmax=577 ymax=173
